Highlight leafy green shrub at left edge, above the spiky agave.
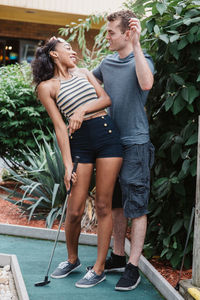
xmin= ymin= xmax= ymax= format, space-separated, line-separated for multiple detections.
xmin=0 ymin=63 xmax=53 ymax=161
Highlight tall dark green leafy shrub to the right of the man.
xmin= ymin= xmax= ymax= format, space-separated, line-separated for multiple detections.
xmin=130 ymin=0 xmax=200 ymax=267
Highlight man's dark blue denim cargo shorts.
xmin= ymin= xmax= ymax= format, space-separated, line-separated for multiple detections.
xmin=112 ymin=142 xmax=154 ymax=218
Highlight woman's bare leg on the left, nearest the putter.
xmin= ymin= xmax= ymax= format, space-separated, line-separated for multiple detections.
xmin=65 ymin=163 xmax=93 ymax=263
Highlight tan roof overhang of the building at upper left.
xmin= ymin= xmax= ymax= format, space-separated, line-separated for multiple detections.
xmin=0 ymin=0 xmax=124 ymax=29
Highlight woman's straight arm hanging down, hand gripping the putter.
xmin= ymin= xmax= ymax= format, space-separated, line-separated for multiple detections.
xmin=37 ymin=82 xmax=75 ymax=190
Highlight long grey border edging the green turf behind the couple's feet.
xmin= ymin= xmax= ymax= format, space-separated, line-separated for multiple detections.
xmin=0 ymin=223 xmax=184 ymax=300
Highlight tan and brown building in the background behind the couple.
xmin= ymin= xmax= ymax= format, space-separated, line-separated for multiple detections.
xmin=0 ymin=0 xmax=124 ymax=66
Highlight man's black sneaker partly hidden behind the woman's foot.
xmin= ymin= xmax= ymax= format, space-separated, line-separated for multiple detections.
xmin=86 ymin=252 xmax=126 ymax=273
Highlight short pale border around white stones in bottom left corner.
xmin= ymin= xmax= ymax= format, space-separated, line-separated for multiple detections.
xmin=0 ymin=253 xmax=29 ymax=300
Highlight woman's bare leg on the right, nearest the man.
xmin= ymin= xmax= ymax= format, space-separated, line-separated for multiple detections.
xmin=94 ymin=157 xmax=122 ymax=275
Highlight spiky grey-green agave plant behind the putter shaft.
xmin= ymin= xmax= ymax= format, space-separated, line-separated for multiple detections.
xmin=3 ymin=134 xmax=66 ymax=228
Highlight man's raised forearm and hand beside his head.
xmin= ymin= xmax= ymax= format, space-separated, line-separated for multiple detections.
xmin=129 ymin=18 xmax=154 ymax=91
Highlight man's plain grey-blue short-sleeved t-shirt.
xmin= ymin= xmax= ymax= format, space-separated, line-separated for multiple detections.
xmin=93 ymin=53 xmax=154 ymax=145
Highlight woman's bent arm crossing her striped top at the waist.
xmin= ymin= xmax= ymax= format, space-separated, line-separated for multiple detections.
xmin=69 ymin=69 xmax=111 ymax=134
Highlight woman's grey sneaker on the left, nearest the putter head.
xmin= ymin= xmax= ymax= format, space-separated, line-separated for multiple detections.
xmin=51 ymin=258 xmax=81 ymax=278
